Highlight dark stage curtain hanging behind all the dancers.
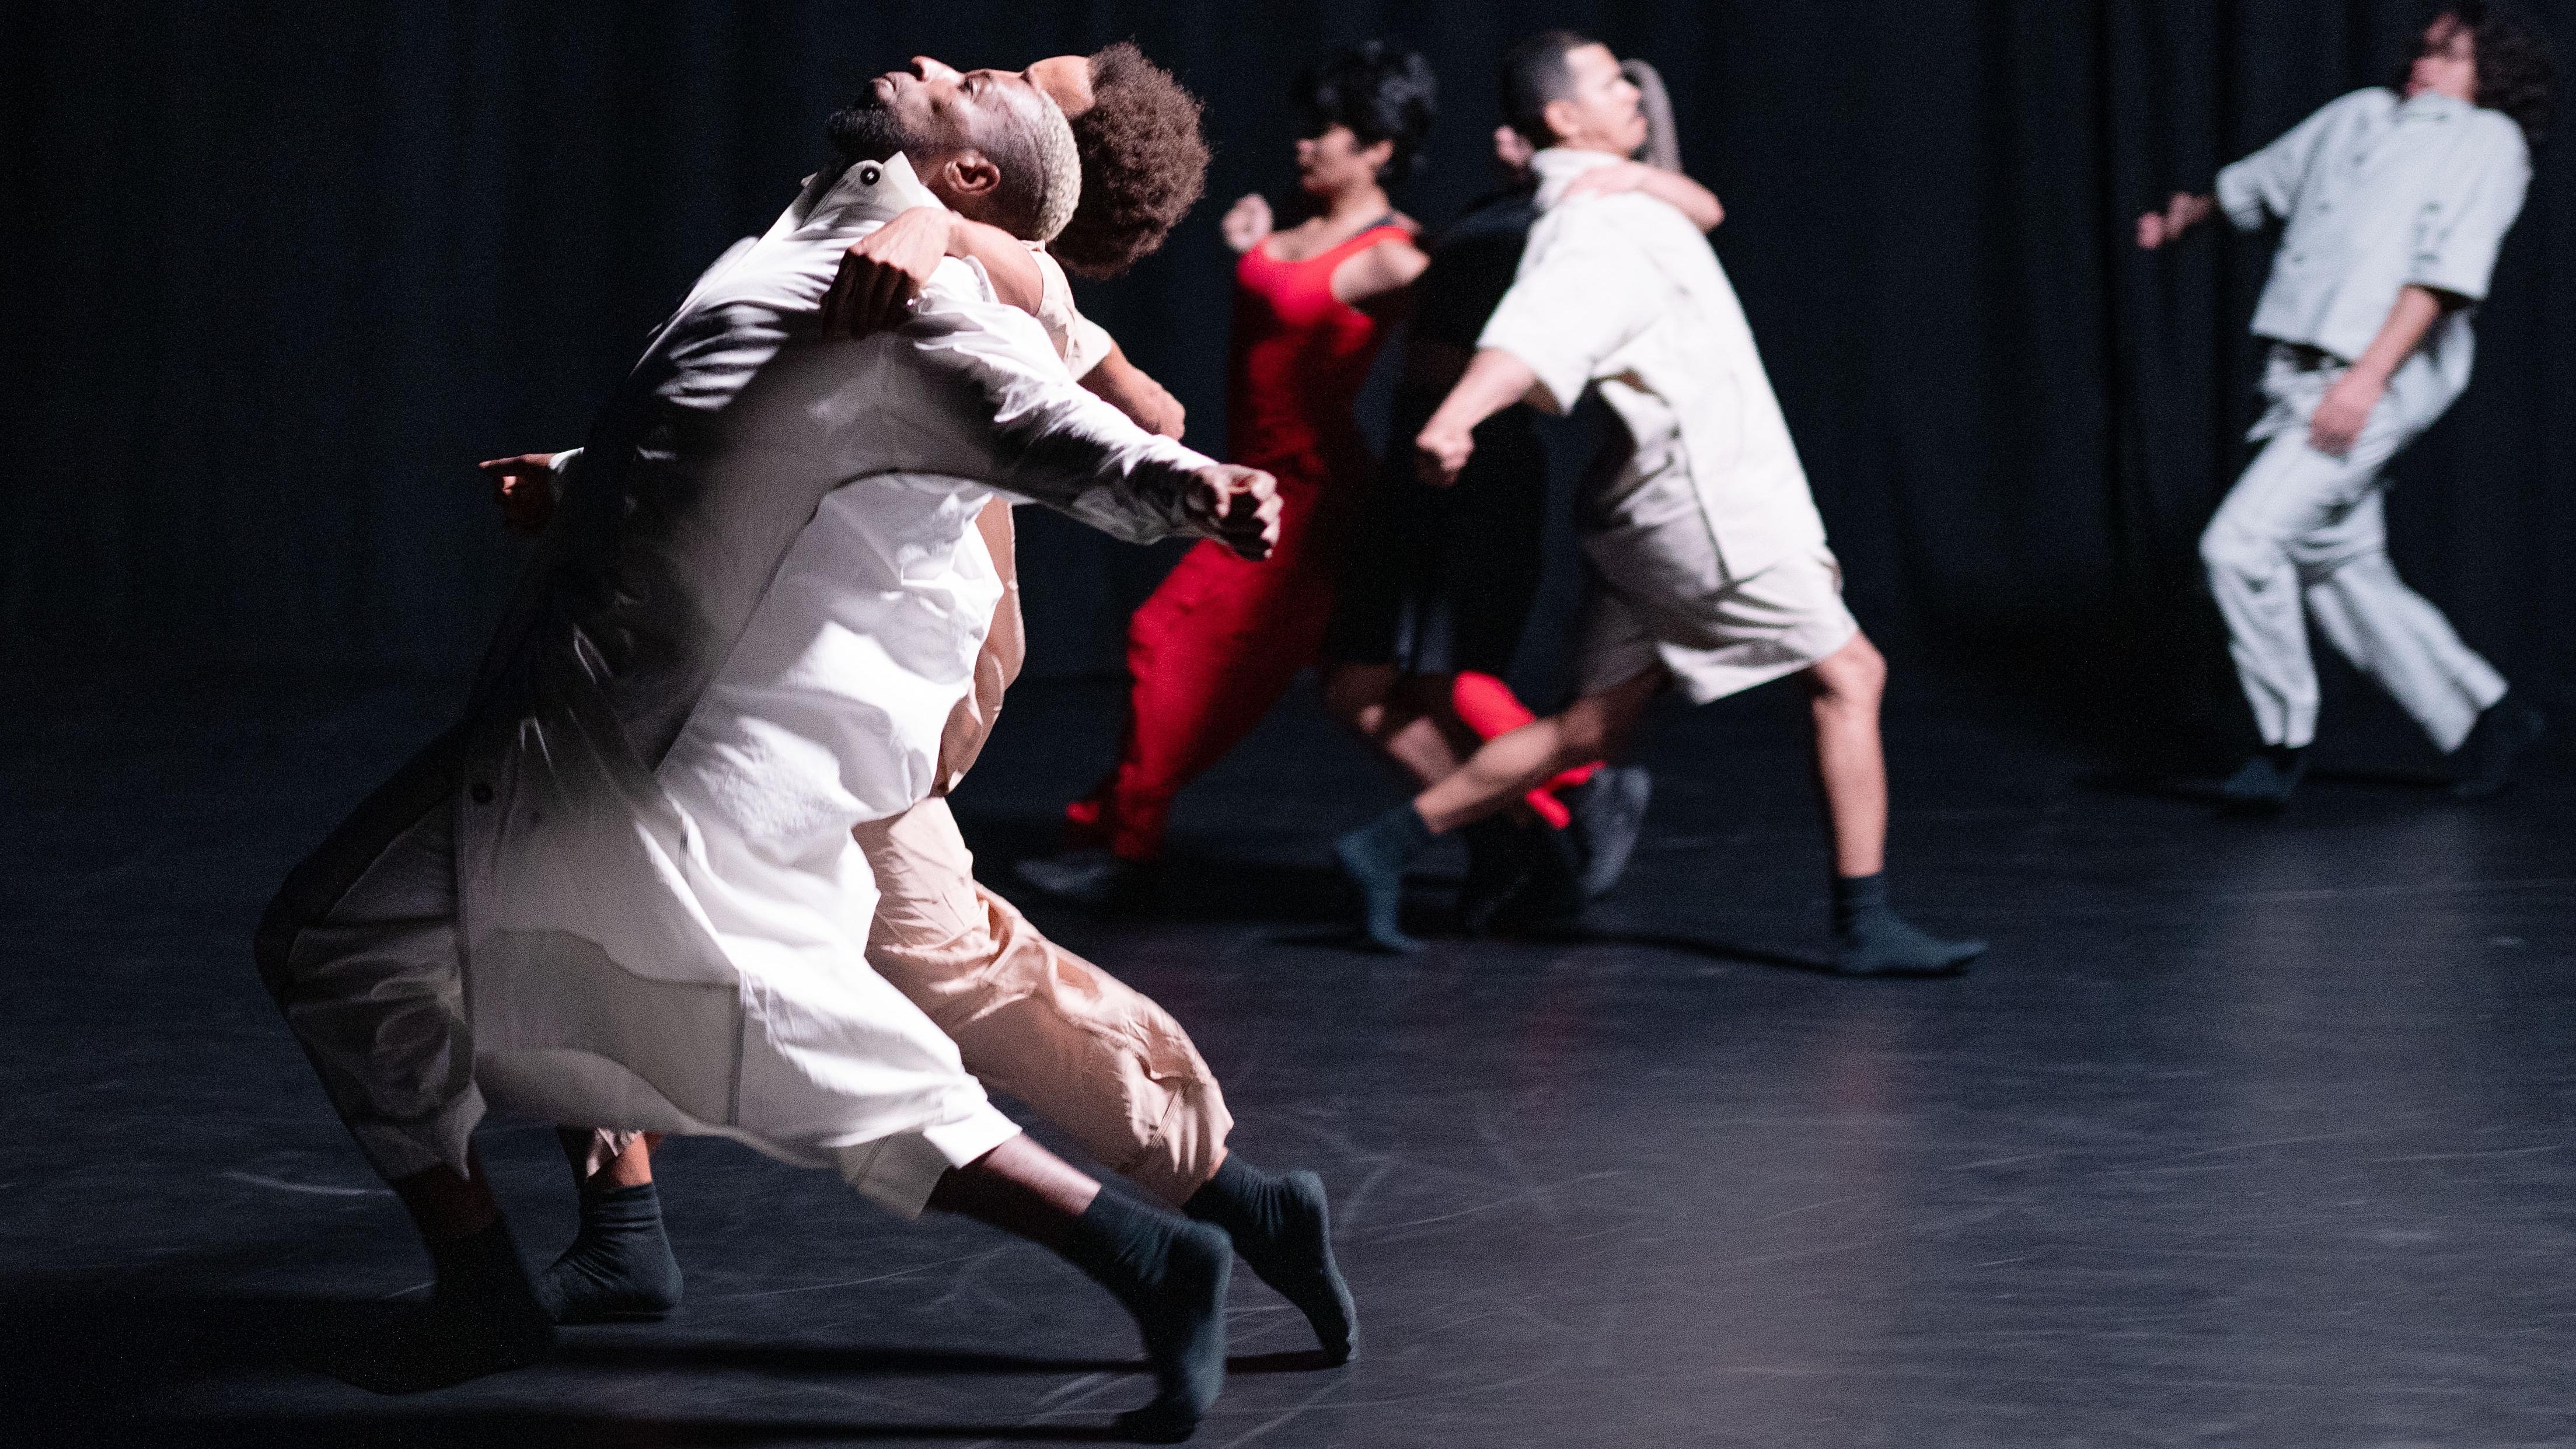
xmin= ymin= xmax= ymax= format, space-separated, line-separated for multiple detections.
xmin=0 ymin=0 xmax=2576 ymax=756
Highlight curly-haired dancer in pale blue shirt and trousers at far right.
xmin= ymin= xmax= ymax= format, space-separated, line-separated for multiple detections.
xmin=2138 ymin=0 xmax=2556 ymax=813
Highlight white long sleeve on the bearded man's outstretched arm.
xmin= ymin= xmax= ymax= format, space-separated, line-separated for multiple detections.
xmin=904 ymin=268 xmax=1213 ymax=543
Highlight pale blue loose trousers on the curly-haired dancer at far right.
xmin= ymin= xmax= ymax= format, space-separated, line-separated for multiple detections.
xmin=2200 ymin=347 xmax=2504 ymax=754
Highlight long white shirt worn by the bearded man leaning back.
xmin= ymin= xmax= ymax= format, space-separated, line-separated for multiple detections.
xmin=456 ymin=159 xmax=1208 ymax=1127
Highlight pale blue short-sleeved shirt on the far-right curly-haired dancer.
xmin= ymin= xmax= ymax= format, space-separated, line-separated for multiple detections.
xmin=2218 ymin=88 xmax=2532 ymax=391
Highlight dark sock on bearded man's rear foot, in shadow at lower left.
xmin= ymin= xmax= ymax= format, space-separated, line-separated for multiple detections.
xmin=332 ymin=1223 xmax=554 ymax=1395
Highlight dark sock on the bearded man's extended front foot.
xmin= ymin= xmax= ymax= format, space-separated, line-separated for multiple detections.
xmin=1064 ymin=1189 xmax=1234 ymax=1438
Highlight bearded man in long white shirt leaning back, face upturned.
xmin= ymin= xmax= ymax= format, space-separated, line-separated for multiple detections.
xmin=246 ymin=54 xmax=1275 ymax=1431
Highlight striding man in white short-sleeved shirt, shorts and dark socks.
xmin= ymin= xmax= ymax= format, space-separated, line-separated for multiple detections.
xmin=1334 ymin=31 xmax=1986 ymax=976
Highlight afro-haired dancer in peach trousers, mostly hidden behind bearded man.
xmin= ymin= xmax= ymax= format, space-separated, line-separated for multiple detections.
xmin=487 ymin=44 xmax=1357 ymax=1364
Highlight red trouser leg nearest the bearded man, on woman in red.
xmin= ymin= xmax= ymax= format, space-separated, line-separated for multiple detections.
xmin=1066 ymin=543 xmax=1332 ymax=860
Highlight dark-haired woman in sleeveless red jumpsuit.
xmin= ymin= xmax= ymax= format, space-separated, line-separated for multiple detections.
xmin=1020 ymin=44 xmax=1435 ymax=903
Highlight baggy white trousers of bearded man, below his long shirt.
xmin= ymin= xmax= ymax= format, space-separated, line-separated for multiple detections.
xmin=257 ymin=739 xmax=1020 ymax=1217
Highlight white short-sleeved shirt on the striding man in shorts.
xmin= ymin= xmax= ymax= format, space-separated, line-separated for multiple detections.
xmin=1476 ymin=146 xmax=1824 ymax=579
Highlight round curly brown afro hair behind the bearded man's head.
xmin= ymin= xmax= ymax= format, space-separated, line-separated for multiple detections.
xmin=1046 ymin=41 xmax=1208 ymax=278
